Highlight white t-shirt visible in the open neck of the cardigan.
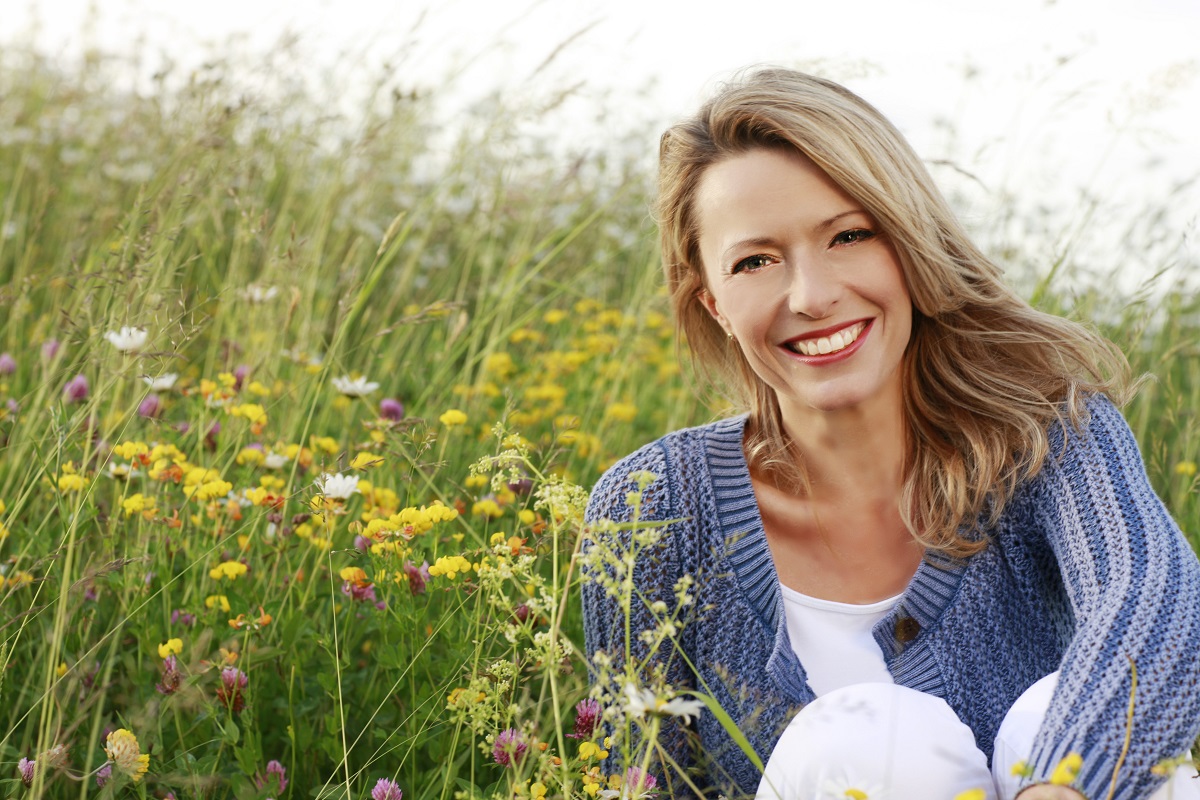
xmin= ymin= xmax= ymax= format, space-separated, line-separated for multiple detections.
xmin=779 ymin=584 xmax=900 ymax=697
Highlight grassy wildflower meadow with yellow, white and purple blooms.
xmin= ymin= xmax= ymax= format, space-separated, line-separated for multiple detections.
xmin=0 ymin=42 xmax=1200 ymax=800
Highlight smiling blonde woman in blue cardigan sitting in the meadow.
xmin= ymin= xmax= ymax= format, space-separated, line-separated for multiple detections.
xmin=583 ymin=70 xmax=1200 ymax=800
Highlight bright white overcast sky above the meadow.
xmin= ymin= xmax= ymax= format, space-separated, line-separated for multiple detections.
xmin=0 ymin=0 xmax=1200 ymax=291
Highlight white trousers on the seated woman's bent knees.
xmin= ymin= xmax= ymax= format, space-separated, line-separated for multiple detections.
xmin=756 ymin=673 xmax=1200 ymax=800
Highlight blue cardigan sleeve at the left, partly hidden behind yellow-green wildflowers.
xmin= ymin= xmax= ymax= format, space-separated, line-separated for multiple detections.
xmin=581 ymin=443 xmax=695 ymax=798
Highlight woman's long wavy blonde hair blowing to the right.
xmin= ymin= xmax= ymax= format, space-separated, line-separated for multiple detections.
xmin=656 ymin=68 xmax=1129 ymax=557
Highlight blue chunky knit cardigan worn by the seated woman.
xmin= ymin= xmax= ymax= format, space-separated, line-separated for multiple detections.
xmin=583 ymin=397 xmax=1200 ymax=800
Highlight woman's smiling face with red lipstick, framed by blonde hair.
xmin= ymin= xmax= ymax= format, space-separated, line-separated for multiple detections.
xmin=696 ymin=149 xmax=912 ymax=420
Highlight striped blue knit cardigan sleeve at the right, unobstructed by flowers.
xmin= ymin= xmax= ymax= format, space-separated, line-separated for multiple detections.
xmin=1028 ymin=396 xmax=1200 ymax=800
